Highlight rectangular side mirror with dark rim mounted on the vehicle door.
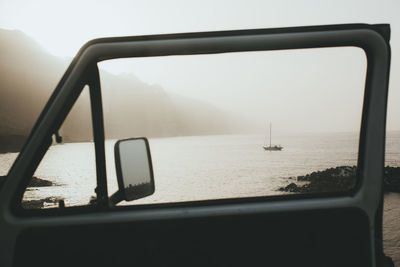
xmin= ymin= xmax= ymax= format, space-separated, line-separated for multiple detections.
xmin=114 ymin=137 xmax=155 ymax=201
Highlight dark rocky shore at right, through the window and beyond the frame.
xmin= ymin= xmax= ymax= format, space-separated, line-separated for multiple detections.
xmin=278 ymin=166 xmax=400 ymax=193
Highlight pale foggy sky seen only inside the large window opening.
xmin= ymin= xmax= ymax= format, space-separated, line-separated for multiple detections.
xmin=100 ymin=47 xmax=366 ymax=132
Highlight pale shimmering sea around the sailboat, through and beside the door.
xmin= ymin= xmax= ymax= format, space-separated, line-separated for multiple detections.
xmin=0 ymin=131 xmax=400 ymax=266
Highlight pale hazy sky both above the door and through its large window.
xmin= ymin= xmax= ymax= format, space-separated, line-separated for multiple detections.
xmin=0 ymin=0 xmax=400 ymax=131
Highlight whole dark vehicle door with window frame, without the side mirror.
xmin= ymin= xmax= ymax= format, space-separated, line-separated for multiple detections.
xmin=0 ymin=24 xmax=390 ymax=266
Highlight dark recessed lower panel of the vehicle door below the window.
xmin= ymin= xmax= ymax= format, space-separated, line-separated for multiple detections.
xmin=14 ymin=209 xmax=371 ymax=267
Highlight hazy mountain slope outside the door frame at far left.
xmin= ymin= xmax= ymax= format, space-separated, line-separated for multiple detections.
xmin=0 ymin=29 xmax=67 ymax=152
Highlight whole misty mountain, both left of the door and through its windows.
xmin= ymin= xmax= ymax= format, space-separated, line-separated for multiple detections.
xmin=0 ymin=29 xmax=240 ymax=152
